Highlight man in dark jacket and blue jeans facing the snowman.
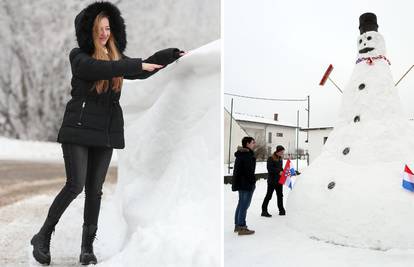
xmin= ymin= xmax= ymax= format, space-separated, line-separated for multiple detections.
xmin=232 ymin=136 xmax=256 ymax=235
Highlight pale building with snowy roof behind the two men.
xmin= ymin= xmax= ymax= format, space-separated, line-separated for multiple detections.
xmin=224 ymin=110 xmax=297 ymax=163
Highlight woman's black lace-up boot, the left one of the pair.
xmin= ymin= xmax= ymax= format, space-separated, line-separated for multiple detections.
xmin=30 ymin=222 xmax=55 ymax=265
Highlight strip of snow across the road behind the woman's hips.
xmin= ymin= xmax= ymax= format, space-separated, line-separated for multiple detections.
xmin=0 ymin=136 xmax=118 ymax=166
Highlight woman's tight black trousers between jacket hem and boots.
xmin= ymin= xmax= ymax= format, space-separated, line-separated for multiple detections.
xmin=47 ymin=144 xmax=113 ymax=228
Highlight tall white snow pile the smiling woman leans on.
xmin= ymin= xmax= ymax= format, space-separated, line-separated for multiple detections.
xmin=99 ymin=41 xmax=221 ymax=266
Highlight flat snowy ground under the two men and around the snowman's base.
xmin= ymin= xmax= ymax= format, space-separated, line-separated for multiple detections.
xmin=224 ymin=180 xmax=414 ymax=267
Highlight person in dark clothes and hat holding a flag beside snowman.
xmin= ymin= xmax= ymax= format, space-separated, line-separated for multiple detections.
xmin=262 ymin=146 xmax=286 ymax=217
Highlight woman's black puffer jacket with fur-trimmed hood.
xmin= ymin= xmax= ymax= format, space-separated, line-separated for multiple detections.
xmin=57 ymin=2 xmax=181 ymax=149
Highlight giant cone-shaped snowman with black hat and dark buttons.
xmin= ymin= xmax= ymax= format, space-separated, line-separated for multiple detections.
xmin=287 ymin=13 xmax=414 ymax=250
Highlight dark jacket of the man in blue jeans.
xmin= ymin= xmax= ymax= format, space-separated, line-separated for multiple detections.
xmin=232 ymin=147 xmax=256 ymax=191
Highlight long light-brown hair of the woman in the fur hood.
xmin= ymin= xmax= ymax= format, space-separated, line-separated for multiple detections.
xmin=92 ymin=12 xmax=124 ymax=94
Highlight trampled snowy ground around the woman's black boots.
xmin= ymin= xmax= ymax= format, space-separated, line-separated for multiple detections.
xmin=0 ymin=184 xmax=117 ymax=267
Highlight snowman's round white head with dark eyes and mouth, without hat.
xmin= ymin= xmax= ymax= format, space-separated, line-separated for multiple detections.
xmin=357 ymin=31 xmax=386 ymax=57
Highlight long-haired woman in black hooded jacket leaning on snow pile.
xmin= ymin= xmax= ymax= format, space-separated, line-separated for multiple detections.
xmin=31 ymin=2 xmax=185 ymax=265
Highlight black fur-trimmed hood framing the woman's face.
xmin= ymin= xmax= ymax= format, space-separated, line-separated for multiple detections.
xmin=75 ymin=2 xmax=127 ymax=55
